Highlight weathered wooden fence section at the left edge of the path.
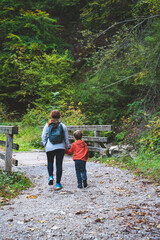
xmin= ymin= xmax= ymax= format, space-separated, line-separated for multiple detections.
xmin=0 ymin=126 xmax=19 ymax=171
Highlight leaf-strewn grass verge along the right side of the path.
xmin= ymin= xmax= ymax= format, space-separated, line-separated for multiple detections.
xmin=92 ymin=152 xmax=160 ymax=183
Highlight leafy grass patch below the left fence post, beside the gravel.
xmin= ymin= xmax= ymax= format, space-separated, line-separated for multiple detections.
xmin=0 ymin=170 xmax=32 ymax=205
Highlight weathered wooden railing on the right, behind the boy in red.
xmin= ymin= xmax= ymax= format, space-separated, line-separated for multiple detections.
xmin=67 ymin=125 xmax=112 ymax=153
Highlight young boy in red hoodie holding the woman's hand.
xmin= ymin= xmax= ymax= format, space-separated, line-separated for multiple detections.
xmin=66 ymin=130 xmax=88 ymax=188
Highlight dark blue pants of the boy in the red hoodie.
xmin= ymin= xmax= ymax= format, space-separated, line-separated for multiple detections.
xmin=74 ymin=160 xmax=87 ymax=187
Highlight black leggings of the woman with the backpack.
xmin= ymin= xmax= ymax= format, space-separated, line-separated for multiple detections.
xmin=46 ymin=149 xmax=65 ymax=183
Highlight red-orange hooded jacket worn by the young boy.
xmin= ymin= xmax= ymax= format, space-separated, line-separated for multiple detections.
xmin=66 ymin=140 xmax=88 ymax=161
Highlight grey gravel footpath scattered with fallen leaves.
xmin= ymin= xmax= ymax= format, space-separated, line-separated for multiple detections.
xmin=0 ymin=152 xmax=160 ymax=240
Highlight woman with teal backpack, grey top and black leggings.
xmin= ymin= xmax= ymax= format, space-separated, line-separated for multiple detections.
xmin=42 ymin=110 xmax=69 ymax=190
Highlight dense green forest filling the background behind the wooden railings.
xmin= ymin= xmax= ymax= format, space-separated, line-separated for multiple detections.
xmin=0 ymin=0 xmax=160 ymax=180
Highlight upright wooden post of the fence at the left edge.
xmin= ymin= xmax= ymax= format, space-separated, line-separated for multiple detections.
xmin=5 ymin=134 xmax=13 ymax=172
